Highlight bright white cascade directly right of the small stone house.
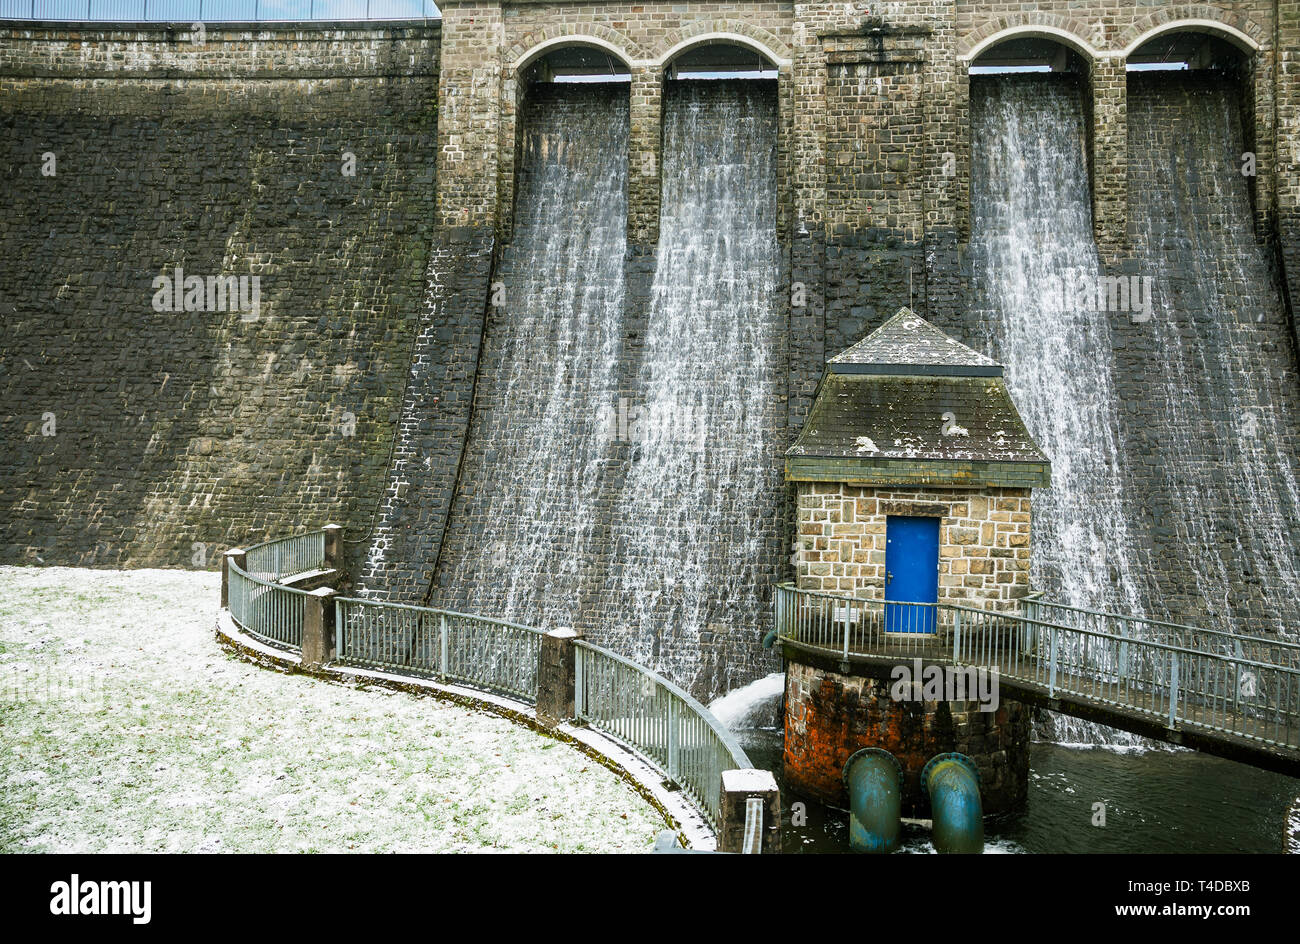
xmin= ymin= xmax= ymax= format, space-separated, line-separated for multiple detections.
xmin=971 ymin=75 xmax=1144 ymax=741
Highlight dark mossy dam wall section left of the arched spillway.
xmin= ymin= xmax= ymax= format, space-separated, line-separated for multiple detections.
xmin=0 ymin=25 xmax=438 ymax=567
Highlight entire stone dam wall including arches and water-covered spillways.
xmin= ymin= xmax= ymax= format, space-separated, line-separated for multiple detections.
xmin=0 ymin=0 xmax=1300 ymax=696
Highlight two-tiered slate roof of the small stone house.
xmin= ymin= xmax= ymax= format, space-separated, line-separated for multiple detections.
xmin=785 ymin=308 xmax=1050 ymax=486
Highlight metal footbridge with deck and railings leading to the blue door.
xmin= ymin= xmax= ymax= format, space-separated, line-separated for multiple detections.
xmin=774 ymin=584 xmax=1300 ymax=776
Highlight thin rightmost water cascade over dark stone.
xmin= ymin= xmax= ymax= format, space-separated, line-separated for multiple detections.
xmin=1128 ymin=74 xmax=1300 ymax=638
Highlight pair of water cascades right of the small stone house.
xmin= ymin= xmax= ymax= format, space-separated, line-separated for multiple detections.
xmin=971 ymin=75 xmax=1300 ymax=742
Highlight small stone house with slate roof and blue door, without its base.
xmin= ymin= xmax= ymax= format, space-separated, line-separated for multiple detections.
xmin=785 ymin=308 xmax=1050 ymax=609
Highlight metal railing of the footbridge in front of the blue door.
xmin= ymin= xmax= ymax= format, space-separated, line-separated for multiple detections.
xmin=775 ymin=584 xmax=1300 ymax=749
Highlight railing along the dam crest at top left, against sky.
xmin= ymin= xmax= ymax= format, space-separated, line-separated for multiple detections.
xmin=0 ymin=0 xmax=442 ymax=25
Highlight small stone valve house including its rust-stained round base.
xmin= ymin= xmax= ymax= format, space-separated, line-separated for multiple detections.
xmin=783 ymin=308 xmax=1050 ymax=818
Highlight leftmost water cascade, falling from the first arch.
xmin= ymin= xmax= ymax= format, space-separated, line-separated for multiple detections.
xmin=433 ymin=85 xmax=628 ymax=627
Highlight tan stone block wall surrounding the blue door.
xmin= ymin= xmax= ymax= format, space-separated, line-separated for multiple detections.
xmin=796 ymin=482 xmax=1032 ymax=609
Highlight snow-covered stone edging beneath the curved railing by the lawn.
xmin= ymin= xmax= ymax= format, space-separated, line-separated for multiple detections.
xmin=217 ymin=610 xmax=718 ymax=852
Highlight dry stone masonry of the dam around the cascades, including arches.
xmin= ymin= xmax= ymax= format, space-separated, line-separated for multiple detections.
xmin=0 ymin=0 xmax=1300 ymax=696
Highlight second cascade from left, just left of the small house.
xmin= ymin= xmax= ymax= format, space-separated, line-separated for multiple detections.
xmin=614 ymin=81 xmax=784 ymax=693
